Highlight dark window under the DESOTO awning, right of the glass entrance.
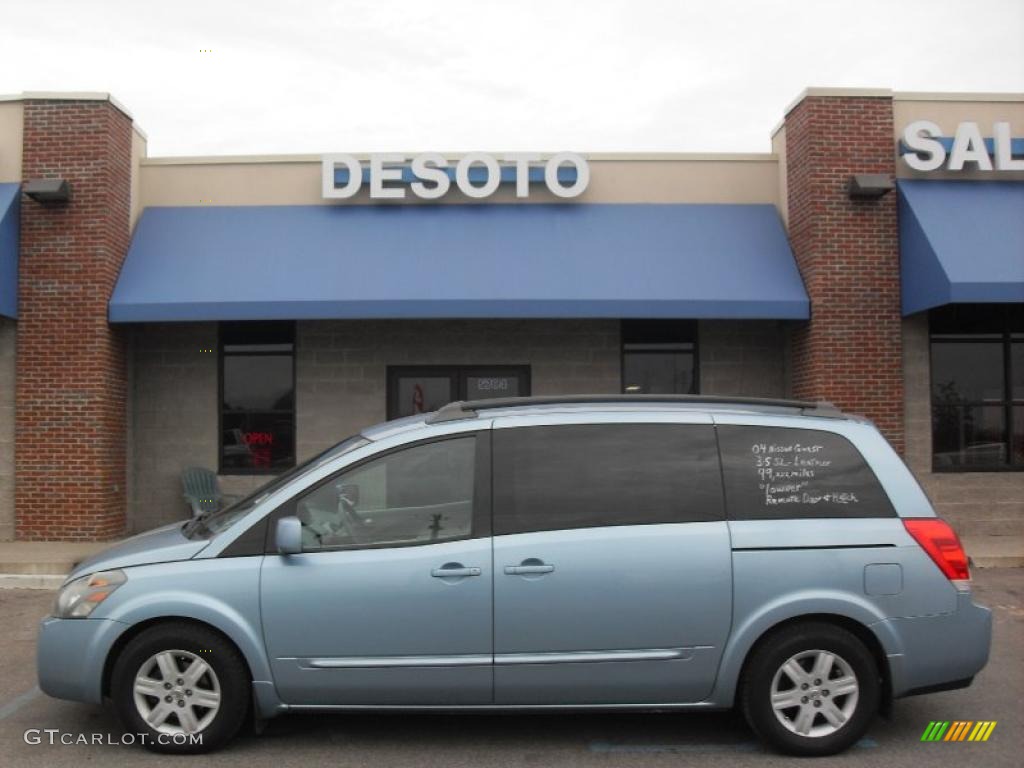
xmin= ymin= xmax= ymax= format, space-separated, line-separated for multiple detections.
xmin=623 ymin=321 xmax=699 ymax=394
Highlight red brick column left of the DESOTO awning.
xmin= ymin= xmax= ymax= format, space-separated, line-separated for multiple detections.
xmin=14 ymin=99 xmax=131 ymax=541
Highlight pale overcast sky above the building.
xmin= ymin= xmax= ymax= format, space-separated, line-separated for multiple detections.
xmin=0 ymin=0 xmax=1024 ymax=156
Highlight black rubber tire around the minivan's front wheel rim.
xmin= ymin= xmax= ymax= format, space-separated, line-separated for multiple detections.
xmin=111 ymin=622 xmax=252 ymax=755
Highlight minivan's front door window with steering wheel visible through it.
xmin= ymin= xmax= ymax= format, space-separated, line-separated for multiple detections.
xmin=295 ymin=435 xmax=476 ymax=550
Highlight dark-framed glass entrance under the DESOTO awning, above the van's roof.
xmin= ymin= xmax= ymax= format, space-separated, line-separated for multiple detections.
xmin=387 ymin=366 xmax=529 ymax=419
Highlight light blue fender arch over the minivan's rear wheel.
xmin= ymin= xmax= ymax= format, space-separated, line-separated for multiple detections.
xmin=710 ymin=590 xmax=903 ymax=708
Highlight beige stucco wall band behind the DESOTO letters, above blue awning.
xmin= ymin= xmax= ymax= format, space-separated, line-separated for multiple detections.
xmin=140 ymin=155 xmax=778 ymax=206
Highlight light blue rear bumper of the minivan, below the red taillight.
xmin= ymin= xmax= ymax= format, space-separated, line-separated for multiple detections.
xmin=880 ymin=592 xmax=992 ymax=698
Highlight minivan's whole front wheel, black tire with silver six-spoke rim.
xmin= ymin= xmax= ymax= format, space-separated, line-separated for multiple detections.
xmin=111 ymin=623 xmax=250 ymax=754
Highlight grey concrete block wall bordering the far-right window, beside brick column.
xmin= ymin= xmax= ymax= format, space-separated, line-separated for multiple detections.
xmin=903 ymin=312 xmax=1024 ymax=537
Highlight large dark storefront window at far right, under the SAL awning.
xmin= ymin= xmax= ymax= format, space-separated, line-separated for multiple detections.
xmin=930 ymin=304 xmax=1024 ymax=471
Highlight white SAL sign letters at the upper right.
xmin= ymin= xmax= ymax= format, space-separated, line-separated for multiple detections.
xmin=902 ymin=120 xmax=1024 ymax=171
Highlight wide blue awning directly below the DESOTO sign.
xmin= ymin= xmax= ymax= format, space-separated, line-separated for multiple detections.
xmin=110 ymin=204 xmax=808 ymax=323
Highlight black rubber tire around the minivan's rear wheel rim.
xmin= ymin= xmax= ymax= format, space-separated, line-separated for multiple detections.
xmin=740 ymin=622 xmax=882 ymax=757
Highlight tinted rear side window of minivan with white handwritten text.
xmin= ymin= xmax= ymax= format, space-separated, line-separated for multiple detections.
xmin=718 ymin=426 xmax=896 ymax=520
